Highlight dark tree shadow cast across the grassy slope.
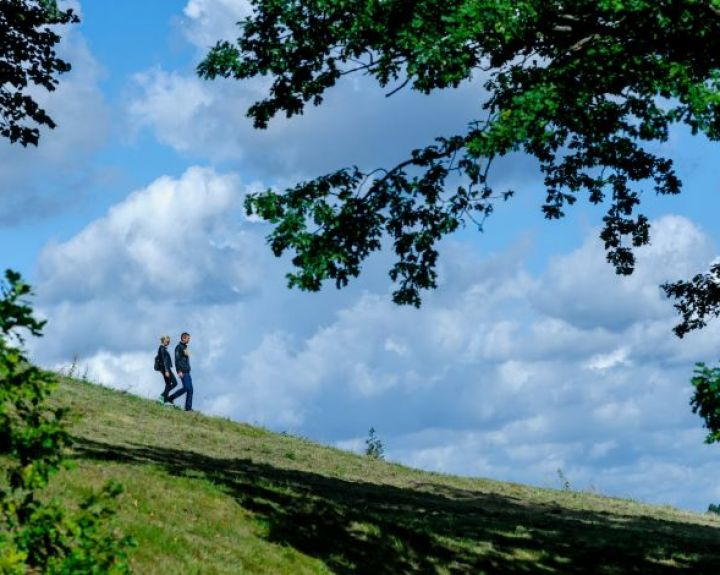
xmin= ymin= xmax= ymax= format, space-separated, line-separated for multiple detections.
xmin=75 ymin=439 xmax=720 ymax=575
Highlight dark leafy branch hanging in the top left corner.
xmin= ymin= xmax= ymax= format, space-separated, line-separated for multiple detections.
xmin=0 ymin=0 xmax=78 ymax=146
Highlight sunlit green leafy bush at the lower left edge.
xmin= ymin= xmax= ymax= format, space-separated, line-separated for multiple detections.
xmin=0 ymin=270 xmax=131 ymax=574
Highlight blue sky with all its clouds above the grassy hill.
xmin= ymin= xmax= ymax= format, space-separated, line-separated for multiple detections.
xmin=0 ymin=0 xmax=720 ymax=511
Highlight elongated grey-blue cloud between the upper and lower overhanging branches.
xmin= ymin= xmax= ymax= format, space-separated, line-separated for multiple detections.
xmin=128 ymin=63 xmax=490 ymax=179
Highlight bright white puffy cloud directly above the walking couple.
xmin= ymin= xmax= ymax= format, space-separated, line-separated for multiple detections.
xmin=39 ymin=168 xmax=264 ymax=301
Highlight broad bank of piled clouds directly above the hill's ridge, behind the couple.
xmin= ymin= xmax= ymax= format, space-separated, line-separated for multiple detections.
xmin=33 ymin=164 xmax=720 ymax=510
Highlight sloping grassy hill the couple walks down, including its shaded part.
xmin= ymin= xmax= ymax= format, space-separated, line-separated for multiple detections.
xmin=31 ymin=380 xmax=720 ymax=575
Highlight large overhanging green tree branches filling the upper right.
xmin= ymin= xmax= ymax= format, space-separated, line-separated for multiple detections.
xmin=198 ymin=0 xmax=720 ymax=336
